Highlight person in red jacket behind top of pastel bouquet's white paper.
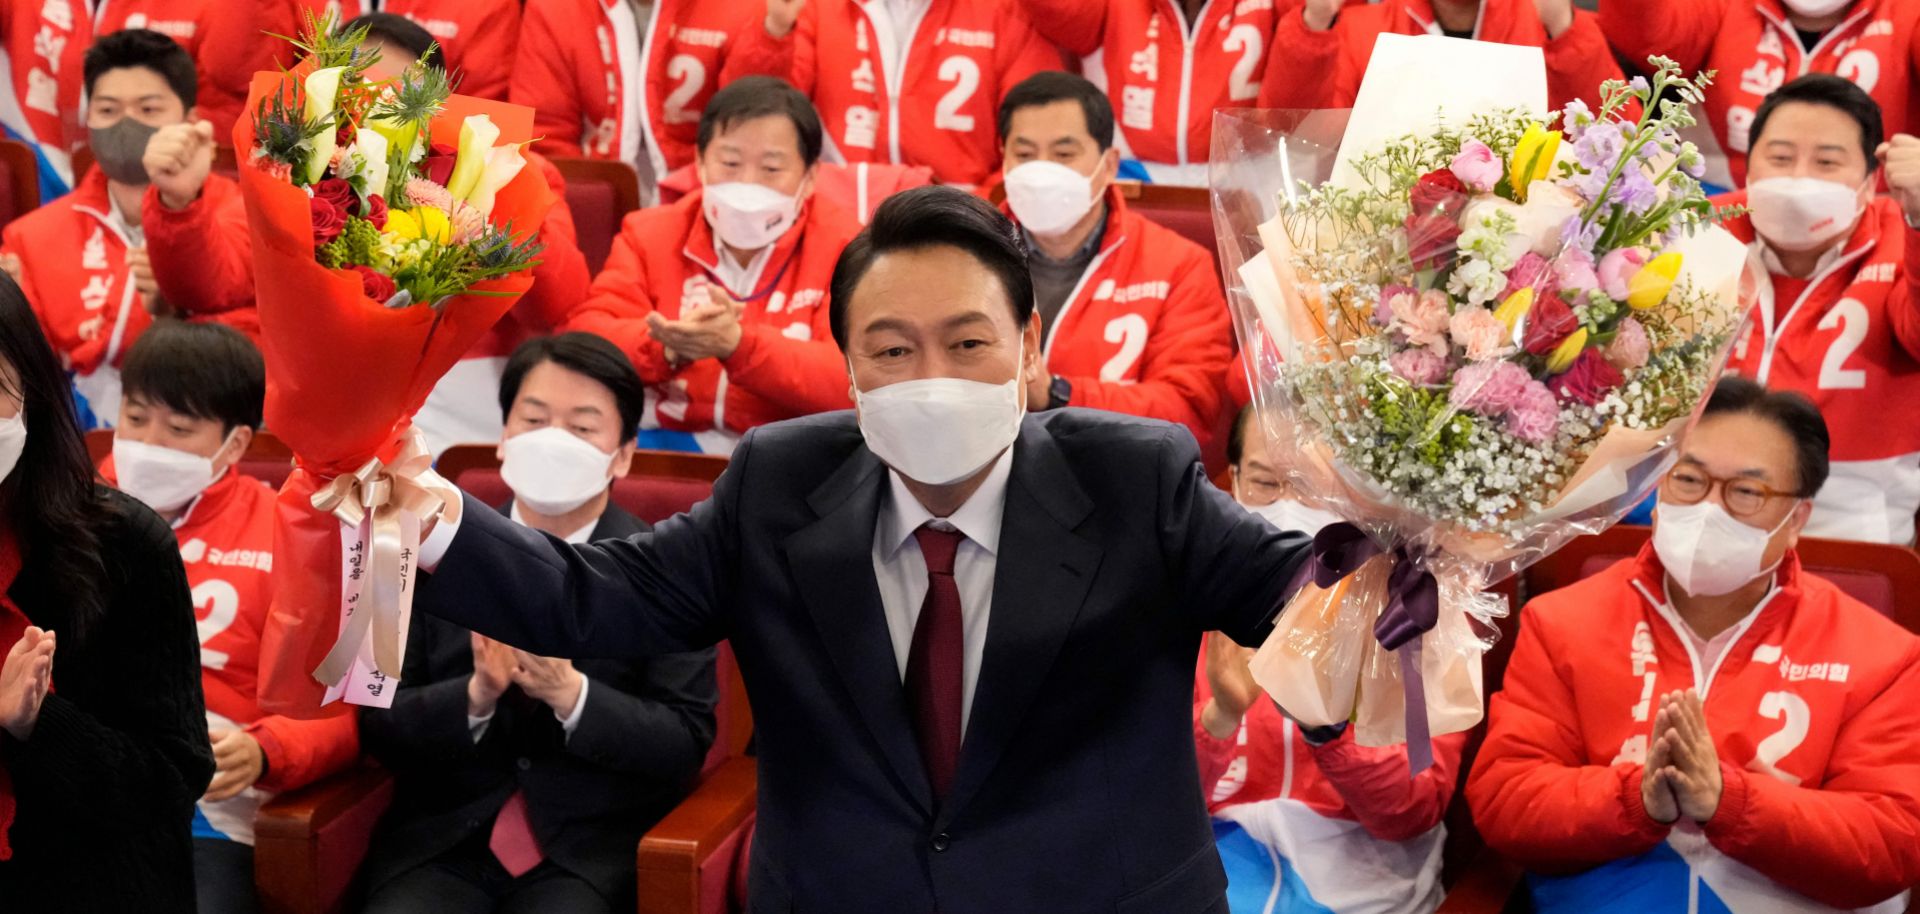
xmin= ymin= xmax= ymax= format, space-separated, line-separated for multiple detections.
xmin=1260 ymin=0 xmax=1628 ymax=115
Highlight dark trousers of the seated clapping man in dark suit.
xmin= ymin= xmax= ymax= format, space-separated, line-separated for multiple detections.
xmin=365 ymin=830 xmax=614 ymax=914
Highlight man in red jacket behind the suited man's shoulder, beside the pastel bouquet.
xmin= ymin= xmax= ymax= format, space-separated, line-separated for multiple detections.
xmin=998 ymin=73 xmax=1233 ymax=449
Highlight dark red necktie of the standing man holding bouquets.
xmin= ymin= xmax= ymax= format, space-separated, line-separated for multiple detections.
xmin=906 ymin=526 xmax=966 ymax=799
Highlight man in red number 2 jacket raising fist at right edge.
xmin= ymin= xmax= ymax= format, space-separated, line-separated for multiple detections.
xmin=1720 ymin=75 xmax=1920 ymax=543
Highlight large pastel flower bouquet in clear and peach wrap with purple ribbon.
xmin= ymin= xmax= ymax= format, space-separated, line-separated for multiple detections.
xmin=1212 ymin=36 xmax=1753 ymax=770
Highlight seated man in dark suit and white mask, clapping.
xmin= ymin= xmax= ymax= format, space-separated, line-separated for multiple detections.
xmin=361 ymin=334 xmax=716 ymax=914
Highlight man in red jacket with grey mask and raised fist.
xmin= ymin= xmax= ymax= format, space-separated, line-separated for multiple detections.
xmin=0 ymin=29 xmax=259 ymax=424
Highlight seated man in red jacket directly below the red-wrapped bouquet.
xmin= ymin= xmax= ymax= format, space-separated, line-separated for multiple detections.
xmin=104 ymin=321 xmax=359 ymax=914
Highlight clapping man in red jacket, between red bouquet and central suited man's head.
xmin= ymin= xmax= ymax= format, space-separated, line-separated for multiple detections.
xmin=563 ymin=77 xmax=860 ymax=453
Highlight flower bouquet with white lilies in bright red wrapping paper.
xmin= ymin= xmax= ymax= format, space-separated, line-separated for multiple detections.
xmin=234 ymin=17 xmax=553 ymax=718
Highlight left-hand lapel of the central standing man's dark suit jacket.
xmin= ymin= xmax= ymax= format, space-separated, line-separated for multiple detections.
xmin=785 ymin=447 xmax=933 ymax=812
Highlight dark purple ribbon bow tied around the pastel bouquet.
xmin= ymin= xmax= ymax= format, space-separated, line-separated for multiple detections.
xmin=1308 ymin=522 xmax=1440 ymax=774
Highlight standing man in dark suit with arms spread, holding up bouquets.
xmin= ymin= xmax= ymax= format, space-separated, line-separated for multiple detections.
xmin=420 ymin=188 xmax=1308 ymax=914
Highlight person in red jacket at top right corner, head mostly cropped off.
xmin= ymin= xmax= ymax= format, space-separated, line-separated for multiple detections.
xmin=1599 ymin=0 xmax=1920 ymax=188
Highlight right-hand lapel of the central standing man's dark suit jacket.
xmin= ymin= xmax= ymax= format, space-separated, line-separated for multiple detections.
xmin=937 ymin=419 xmax=1102 ymax=826
